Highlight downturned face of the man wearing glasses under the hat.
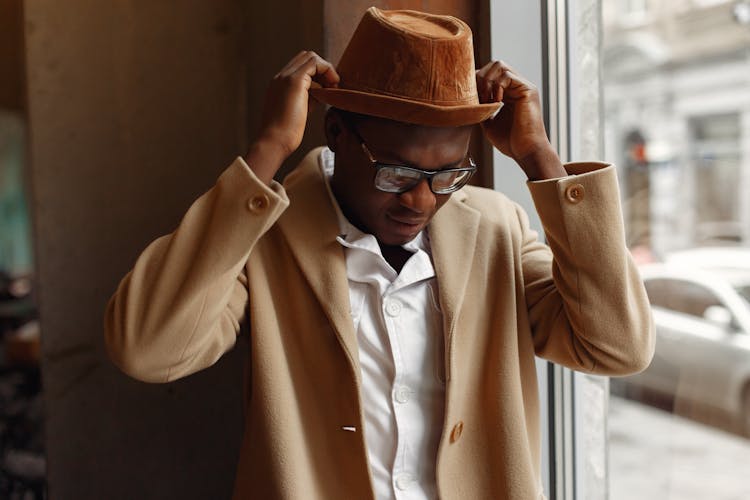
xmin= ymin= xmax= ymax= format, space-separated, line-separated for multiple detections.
xmin=326 ymin=111 xmax=471 ymax=245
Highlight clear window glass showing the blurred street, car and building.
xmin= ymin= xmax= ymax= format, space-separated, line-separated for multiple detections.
xmin=602 ymin=0 xmax=750 ymax=500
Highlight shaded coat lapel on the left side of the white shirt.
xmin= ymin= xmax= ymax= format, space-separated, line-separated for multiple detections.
xmin=278 ymin=148 xmax=359 ymax=374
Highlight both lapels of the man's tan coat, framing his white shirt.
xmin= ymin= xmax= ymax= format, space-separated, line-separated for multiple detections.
xmin=278 ymin=148 xmax=480 ymax=377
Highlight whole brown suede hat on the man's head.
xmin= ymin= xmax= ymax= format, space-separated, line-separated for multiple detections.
xmin=310 ymin=7 xmax=502 ymax=127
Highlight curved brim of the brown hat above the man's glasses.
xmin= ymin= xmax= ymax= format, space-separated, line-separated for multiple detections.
xmin=310 ymin=87 xmax=503 ymax=127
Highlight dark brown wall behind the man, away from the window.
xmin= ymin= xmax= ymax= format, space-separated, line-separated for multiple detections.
xmin=23 ymin=0 xmax=488 ymax=500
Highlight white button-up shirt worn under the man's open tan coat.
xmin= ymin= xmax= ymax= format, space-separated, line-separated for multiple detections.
xmin=337 ymin=220 xmax=436 ymax=500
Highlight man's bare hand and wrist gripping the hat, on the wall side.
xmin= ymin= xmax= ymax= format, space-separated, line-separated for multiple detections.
xmin=246 ymin=51 xmax=339 ymax=184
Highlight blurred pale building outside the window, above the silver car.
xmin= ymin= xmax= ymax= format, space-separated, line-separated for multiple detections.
xmin=603 ymin=0 xmax=750 ymax=257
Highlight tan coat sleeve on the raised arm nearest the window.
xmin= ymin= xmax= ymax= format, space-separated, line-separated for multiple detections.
xmin=518 ymin=163 xmax=654 ymax=375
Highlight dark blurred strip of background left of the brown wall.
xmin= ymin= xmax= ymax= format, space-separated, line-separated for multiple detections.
xmin=0 ymin=0 xmax=41 ymax=499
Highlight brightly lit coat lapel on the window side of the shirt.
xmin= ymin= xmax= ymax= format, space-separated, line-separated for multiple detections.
xmin=429 ymin=191 xmax=480 ymax=380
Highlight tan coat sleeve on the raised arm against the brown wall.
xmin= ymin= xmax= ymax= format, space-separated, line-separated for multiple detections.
xmin=104 ymin=158 xmax=289 ymax=382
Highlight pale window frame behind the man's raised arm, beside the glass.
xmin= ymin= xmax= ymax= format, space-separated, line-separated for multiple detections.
xmin=488 ymin=0 xmax=609 ymax=500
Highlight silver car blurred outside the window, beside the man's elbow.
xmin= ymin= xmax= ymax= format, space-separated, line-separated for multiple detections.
xmin=613 ymin=259 xmax=750 ymax=436
